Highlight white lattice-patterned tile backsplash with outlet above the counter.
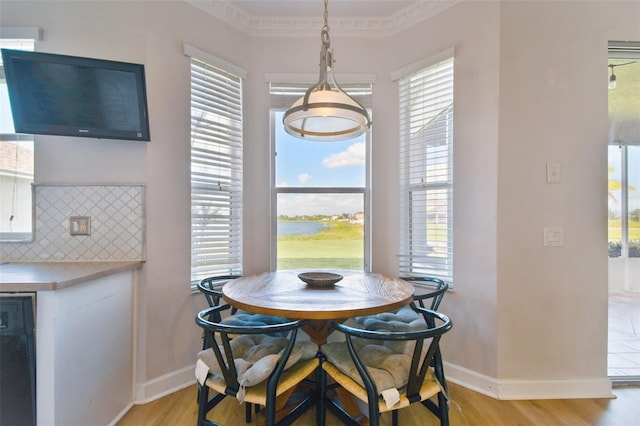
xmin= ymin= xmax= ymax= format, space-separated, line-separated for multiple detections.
xmin=0 ymin=184 xmax=145 ymax=262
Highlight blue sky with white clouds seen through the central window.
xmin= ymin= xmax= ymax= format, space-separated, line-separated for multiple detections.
xmin=275 ymin=112 xmax=366 ymax=216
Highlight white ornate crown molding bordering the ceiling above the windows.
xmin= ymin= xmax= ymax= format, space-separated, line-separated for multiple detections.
xmin=184 ymin=0 xmax=463 ymax=37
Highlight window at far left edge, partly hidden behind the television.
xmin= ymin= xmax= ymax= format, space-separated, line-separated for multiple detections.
xmin=0 ymin=39 xmax=35 ymax=241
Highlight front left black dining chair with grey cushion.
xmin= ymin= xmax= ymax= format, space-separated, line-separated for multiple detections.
xmin=196 ymin=305 xmax=320 ymax=426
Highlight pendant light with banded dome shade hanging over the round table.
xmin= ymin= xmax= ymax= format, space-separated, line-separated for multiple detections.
xmin=282 ymin=0 xmax=371 ymax=141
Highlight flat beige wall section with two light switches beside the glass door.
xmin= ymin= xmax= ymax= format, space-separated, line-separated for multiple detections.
xmin=497 ymin=1 xmax=640 ymax=399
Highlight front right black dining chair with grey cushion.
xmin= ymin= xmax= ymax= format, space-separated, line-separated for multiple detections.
xmin=318 ymin=306 xmax=452 ymax=426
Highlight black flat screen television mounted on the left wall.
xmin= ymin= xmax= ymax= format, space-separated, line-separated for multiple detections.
xmin=2 ymin=49 xmax=150 ymax=141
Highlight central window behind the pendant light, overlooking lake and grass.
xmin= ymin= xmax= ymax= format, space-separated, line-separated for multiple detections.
xmin=270 ymin=83 xmax=371 ymax=270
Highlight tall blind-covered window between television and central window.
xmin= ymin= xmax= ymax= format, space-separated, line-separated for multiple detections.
xmin=185 ymin=45 xmax=245 ymax=285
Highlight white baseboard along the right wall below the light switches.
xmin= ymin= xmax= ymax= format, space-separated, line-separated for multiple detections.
xmin=445 ymin=363 xmax=615 ymax=400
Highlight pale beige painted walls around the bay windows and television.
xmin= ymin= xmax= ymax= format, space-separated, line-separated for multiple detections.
xmin=0 ymin=1 xmax=640 ymax=400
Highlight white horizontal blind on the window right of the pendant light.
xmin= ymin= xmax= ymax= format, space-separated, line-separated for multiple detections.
xmin=399 ymin=58 xmax=453 ymax=283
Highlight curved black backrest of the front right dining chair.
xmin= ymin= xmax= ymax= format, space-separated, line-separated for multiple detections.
xmin=335 ymin=307 xmax=452 ymax=401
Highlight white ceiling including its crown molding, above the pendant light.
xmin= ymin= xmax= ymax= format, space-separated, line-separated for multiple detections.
xmin=185 ymin=0 xmax=462 ymax=37
